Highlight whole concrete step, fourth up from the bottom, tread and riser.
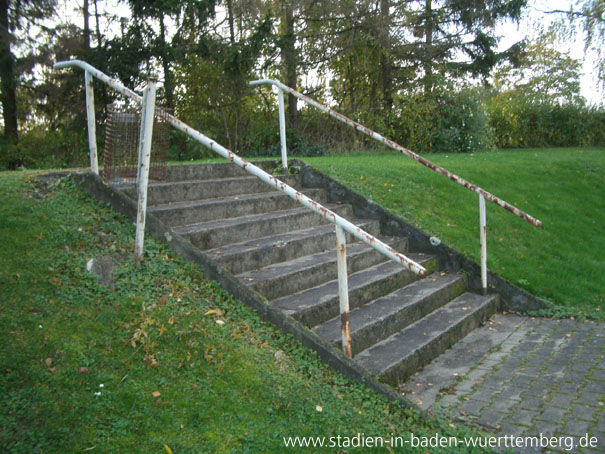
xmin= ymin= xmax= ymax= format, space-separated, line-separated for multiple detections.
xmin=238 ymin=238 xmax=407 ymax=301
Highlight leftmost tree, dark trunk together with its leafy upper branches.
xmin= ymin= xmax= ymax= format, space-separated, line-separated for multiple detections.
xmin=0 ymin=0 xmax=56 ymax=143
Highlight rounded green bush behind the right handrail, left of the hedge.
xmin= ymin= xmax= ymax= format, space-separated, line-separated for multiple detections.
xmin=390 ymin=86 xmax=493 ymax=153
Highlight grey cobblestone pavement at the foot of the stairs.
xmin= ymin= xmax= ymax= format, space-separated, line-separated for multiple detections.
xmin=401 ymin=314 xmax=605 ymax=453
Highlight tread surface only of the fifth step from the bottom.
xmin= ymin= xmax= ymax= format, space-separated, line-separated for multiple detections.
xmin=206 ymin=219 xmax=374 ymax=260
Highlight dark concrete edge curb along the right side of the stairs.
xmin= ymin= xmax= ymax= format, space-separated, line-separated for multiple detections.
xmin=298 ymin=159 xmax=547 ymax=311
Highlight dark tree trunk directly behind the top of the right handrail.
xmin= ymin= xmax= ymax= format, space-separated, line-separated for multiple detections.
xmin=281 ymin=0 xmax=298 ymax=129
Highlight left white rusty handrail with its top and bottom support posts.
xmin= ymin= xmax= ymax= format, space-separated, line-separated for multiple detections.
xmin=54 ymin=60 xmax=427 ymax=357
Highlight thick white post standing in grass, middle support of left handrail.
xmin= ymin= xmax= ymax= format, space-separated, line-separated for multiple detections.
xmin=134 ymin=79 xmax=156 ymax=264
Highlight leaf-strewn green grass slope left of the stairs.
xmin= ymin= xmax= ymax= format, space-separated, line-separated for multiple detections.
xmin=0 ymin=173 xmax=486 ymax=454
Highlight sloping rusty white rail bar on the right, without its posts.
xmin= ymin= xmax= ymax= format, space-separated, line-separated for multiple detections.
xmin=250 ymin=79 xmax=542 ymax=227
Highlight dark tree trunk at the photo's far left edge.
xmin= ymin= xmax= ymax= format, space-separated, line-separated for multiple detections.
xmin=0 ymin=0 xmax=18 ymax=143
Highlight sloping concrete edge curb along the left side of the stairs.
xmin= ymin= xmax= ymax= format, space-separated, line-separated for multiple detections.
xmin=72 ymin=173 xmax=424 ymax=418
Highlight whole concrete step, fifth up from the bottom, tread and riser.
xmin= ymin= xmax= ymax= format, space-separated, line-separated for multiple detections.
xmin=206 ymin=220 xmax=380 ymax=274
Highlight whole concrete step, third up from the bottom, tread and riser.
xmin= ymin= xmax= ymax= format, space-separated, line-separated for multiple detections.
xmin=273 ymin=253 xmax=437 ymax=327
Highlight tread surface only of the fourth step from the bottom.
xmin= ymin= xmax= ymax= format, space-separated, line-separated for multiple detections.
xmin=237 ymin=238 xmax=397 ymax=286
